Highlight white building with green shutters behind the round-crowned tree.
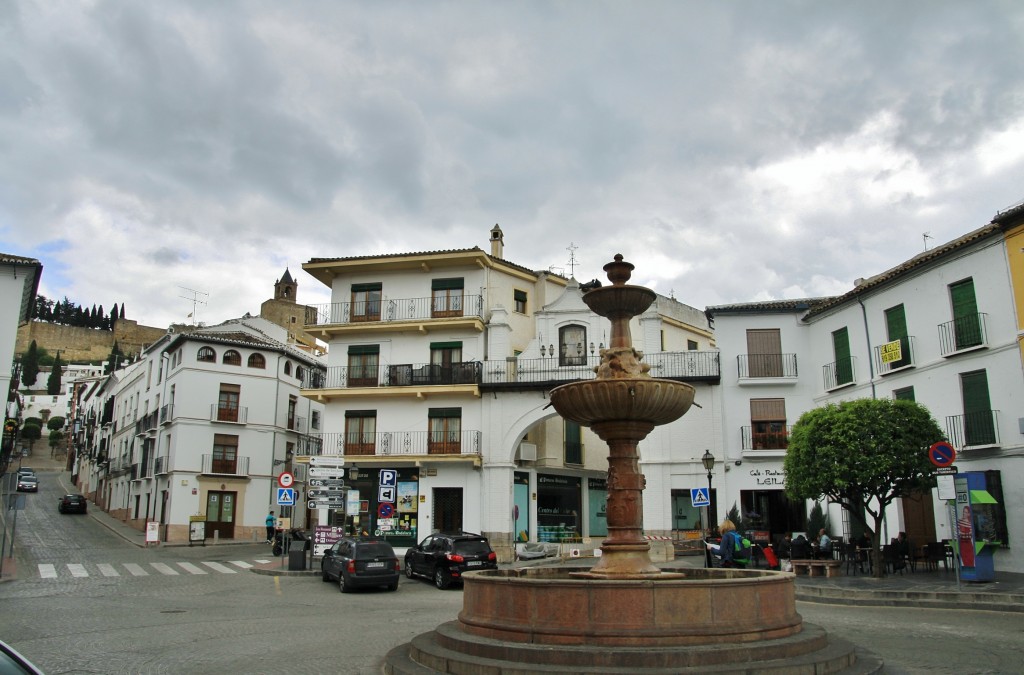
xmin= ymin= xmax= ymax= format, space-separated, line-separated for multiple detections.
xmin=708 ymin=213 xmax=1024 ymax=573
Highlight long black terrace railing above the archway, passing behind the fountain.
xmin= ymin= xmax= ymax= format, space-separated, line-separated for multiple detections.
xmin=481 ymin=351 xmax=721 ymax=384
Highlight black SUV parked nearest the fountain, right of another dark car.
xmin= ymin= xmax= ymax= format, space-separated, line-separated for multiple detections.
xmin=406 ymin=532 xmax=498 ymax=589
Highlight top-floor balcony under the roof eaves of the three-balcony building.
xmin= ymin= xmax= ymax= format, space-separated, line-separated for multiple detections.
xmin=305 ymin=294 xmax=483 ymax=335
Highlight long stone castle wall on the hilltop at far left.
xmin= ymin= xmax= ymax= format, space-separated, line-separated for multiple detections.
xmin=14 ymin=319 xmax=167 ymax=363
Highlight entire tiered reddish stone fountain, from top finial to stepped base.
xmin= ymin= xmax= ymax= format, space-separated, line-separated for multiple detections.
xmin=384 ymin=255 xmax=882 ymax=675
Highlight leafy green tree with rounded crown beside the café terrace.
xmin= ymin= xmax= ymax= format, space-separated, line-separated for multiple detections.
xmin=784 ymin=398 xmax=944 ymax=577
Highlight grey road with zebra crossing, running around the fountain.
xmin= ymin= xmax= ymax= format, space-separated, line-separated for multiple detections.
xmin=0 ymin=473 xmax=1024 ymax=675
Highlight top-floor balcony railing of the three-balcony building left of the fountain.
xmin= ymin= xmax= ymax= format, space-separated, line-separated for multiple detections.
xmin=308 ymin=294 xmax=483 ymax=326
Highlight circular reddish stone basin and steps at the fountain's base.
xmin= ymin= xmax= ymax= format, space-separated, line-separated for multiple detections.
xmin=384 ymin=567 xmax=882 ymax=675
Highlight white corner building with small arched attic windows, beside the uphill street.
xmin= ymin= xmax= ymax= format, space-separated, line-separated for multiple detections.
xmin=74 ymin=318 xmax=324 ymax=542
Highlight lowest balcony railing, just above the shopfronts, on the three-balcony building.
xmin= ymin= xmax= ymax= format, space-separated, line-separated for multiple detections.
xmin=296 ymin=431 xmax=482 ymax=457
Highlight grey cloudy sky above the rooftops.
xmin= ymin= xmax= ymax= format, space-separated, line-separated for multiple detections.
xmin=0 ymin=0 xmax=1024 ymax=327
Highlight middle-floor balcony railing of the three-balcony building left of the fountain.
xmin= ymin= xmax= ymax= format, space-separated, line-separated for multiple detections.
xmin=302 ymin=361 xmax=481 ymax=389
